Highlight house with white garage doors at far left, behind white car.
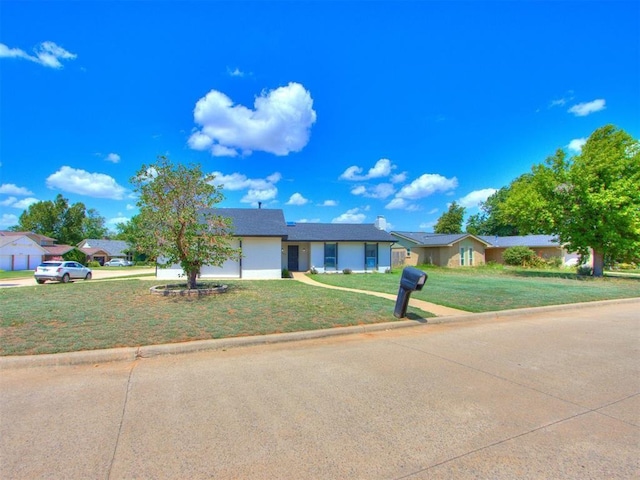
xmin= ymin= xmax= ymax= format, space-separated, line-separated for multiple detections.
xmin=0 ymin=231 xmax=75 ymax=270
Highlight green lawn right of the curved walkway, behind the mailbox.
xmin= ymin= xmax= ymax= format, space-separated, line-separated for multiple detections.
xmin=311 ymin=267 xmax=640 ymax=312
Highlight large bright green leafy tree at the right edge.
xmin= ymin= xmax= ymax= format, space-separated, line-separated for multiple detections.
xmin=505 ymin=125 xmax=640 ymax=276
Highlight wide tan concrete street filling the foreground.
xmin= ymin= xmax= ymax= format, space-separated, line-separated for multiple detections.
xmin=0 ymin=300 xmax=640 ymax=479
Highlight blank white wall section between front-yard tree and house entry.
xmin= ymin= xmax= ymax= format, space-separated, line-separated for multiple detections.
xmin=242 ymin=237 xmax=282 ymax=279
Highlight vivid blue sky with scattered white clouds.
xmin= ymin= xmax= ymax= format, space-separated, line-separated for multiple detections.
xmin=0 ymin=0 xmax=640 ymax=231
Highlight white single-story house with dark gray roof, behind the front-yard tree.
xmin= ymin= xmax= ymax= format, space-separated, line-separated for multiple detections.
xmin=157 ymin=208 xmax=394 ymax=279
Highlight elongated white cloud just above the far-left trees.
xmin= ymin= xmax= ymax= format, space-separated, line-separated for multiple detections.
xmin=47 ymin=166 xmax=126 ymax=200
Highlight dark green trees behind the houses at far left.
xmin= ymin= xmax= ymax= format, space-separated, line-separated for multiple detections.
xmin=14 ymin=194 xmax=106 ymax=245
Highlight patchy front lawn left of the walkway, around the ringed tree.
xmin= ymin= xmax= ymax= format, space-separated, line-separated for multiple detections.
xmin=0 ymin=280 xmax=432 ymax=355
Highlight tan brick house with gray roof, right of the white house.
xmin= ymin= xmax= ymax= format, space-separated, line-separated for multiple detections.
xmin=391 ymin=232 xmax=570 ymax=267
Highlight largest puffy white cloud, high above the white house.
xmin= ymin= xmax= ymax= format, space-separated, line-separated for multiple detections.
xmin=188 ymin=82 xmax=316 ymax=156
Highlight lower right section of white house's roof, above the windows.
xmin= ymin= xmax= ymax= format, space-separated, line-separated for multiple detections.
xmin=287 ymin=223 xmax=395 ymax=242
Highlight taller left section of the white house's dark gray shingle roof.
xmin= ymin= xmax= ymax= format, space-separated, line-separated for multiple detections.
xmin=204 ymin=208 xmax=287 ymax=237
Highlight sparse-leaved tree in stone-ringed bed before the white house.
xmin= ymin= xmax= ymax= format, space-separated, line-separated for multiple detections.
xmin=131 ymin=156 xmax=239 ymax=288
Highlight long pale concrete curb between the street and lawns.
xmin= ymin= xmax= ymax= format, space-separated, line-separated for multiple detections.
xmin=0 ymin=298 xmax=640 ymax=370
